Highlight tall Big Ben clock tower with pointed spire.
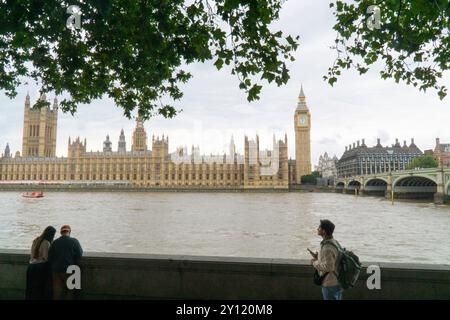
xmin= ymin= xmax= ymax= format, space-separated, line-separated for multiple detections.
xmin=294 ymin=86 xmax=311 ymax=184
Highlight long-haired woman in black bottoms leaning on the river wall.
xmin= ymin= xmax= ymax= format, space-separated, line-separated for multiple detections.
xmin=26 ymin=226 xmax=56 ymax=300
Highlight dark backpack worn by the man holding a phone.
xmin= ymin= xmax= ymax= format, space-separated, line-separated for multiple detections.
xmin=323 ymin=239 xmax=361 ymax=289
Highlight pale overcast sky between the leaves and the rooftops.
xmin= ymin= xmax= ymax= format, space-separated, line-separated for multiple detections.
xmin=0 ymin=0 xmax=450 ymax=164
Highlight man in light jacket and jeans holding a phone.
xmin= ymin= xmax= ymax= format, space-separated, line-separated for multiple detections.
xmin=308 ymin=220 xmax=343 ymax=300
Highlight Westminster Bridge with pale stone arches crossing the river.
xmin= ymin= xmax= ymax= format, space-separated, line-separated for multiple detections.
xmin=335 ymin=167 xmax=450 ymax=204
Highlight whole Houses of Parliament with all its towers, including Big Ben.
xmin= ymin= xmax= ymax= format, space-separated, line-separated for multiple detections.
xmin=0 ymin=88 xmax=311 ymax=189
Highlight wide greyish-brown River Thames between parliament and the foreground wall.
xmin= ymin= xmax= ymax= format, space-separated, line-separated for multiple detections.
xmin=0 ymin=192 xmax=450 ymax=264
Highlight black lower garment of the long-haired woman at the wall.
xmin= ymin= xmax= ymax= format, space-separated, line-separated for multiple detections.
xmin=25 ymin=262 xmax=52 ymax=300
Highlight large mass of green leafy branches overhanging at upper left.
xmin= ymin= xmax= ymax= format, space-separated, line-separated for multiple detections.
xmin=0 ymin=0 xmax=299 ymax=117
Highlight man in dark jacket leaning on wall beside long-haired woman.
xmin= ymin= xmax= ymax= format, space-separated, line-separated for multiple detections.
xmin=48 ymin=225 xmax=83 ymax=300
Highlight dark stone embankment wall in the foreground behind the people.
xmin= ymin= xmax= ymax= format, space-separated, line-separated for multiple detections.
xmin=0 ymin=250 xmax=450 ymax=300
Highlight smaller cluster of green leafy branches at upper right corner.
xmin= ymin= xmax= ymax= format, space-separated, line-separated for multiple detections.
xmin=327 ymin=0 xmax=450 ymax=99
